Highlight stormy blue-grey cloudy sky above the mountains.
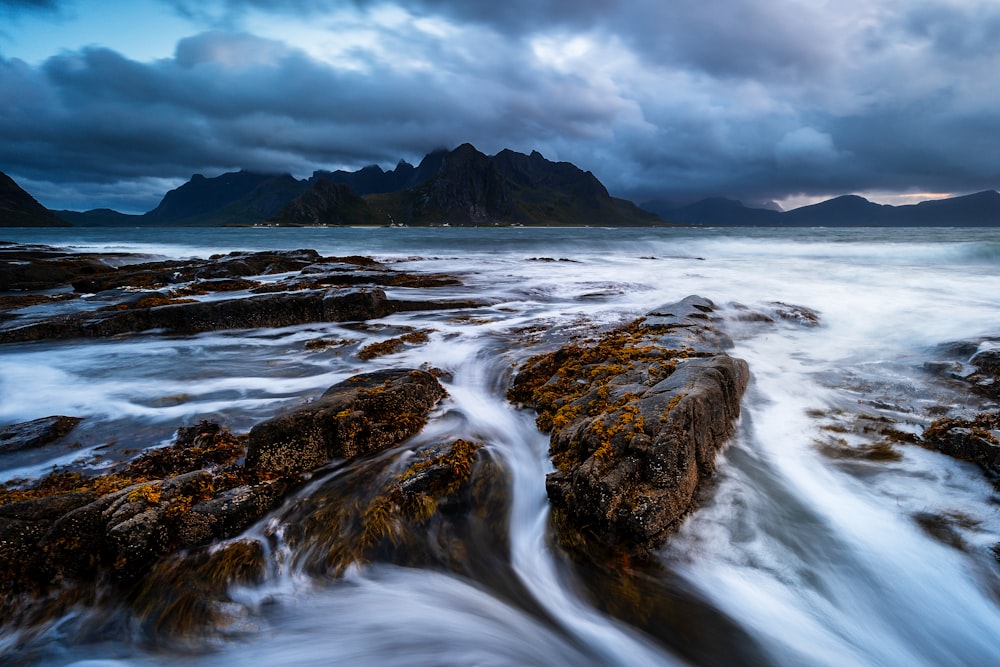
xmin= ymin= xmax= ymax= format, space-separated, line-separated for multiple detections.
xmin=0 ymin=0 xmax=1000 ymax=212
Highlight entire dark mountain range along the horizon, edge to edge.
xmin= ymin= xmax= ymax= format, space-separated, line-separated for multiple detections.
xmin=0 ymin=144 xmax=1000 ymax=227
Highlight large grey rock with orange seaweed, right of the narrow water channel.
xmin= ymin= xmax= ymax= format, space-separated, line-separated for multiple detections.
xmin=509 ymin=297 xmax=749 ymax=557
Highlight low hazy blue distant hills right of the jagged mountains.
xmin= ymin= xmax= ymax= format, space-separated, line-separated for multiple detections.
xmin=647 ymin=190 xmax=1000 ymax=227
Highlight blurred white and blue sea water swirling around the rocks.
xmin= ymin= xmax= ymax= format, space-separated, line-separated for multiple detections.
xmin=0 ymin=228 xmax=1000 ymax=667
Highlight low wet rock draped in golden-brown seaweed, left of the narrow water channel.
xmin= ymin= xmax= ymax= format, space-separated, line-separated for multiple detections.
xmin=277 ymin=439 xmax=508 ymax=576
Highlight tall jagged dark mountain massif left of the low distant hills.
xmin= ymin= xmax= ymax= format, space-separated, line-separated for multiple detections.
xmin=41 ymin=144 xmax=660 ymax=227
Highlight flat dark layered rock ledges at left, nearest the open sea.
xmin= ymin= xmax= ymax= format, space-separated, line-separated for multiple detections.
xmin=0 ymin=247 xmax=483 ymax=343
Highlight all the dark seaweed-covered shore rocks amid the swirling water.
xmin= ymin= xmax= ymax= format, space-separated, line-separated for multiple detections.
xmin=0 ymin=246 xmax=1000 ymax=635
